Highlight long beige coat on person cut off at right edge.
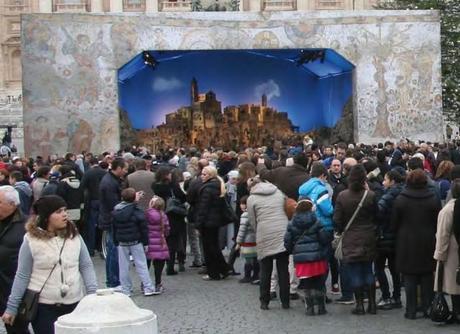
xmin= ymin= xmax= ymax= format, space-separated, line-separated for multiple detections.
xmin=434 ymin=199 xmax=460 ymax=295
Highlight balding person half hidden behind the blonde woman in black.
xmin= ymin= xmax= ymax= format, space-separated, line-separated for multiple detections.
xmin=184 ymin=159 xmax=209 ymax=268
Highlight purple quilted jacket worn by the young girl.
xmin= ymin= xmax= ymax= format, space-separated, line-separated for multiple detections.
xmin=145 ymin=208 xmax=169 ymax=260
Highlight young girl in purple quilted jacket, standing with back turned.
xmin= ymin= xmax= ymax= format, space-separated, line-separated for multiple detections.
xmin=146 ymin=196 xmax=170 ymax=295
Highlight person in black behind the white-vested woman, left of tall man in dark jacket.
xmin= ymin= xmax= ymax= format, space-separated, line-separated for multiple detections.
xmin=80 ymin=158 xmax=107 ymax=256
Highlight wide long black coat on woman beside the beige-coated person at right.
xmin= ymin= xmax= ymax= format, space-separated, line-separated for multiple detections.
xmin=391 ymin=187 xmax=441 ymax=275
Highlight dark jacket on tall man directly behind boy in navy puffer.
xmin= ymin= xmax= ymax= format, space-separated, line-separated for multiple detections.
xmin=99 ymin=172 xmax=121 ymax=230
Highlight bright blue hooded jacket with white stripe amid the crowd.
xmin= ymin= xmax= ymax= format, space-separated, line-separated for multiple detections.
xmin=299 ymin=177 xmax=334 ymax=231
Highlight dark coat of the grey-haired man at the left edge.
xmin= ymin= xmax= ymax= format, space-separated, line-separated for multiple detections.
xmin=0 ymin=209 xmax=25 ymax=314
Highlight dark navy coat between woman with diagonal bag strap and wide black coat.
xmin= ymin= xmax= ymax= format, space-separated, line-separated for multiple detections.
xmin=377 ymin=184 xmax=404 ymax=254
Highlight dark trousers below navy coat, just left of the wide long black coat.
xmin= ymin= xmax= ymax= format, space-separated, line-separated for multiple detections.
xmin=375 ymin=253 xmax=401 ymax=299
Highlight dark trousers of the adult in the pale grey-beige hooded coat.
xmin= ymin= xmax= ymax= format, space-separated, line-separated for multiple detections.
xmin=260 ymin=252 xmax=289 ymax=305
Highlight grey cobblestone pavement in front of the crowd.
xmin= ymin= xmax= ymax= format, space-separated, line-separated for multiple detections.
xmin=0 ymin=257 xmax=460 ymax=334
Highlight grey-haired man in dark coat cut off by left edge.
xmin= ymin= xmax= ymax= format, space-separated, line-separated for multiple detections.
xmin=0 ymin=186 xmax=29 ymax=334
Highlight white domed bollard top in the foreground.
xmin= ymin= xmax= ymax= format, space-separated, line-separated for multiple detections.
xmin=54 ymin=289 xmax=158 ymax=334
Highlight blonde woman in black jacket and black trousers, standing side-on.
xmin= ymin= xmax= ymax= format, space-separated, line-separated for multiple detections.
xmin=195 ymin=166 xmax=229 ymax=281
